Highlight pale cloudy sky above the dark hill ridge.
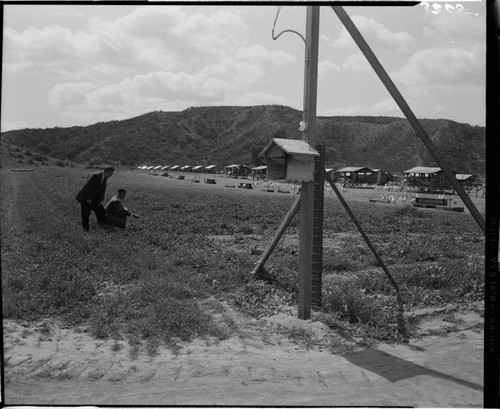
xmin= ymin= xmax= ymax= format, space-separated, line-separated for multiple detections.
xmin=1 ymin=0 xmax=486 ymax=131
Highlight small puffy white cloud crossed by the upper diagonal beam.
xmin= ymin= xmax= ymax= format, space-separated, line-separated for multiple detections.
xmin=324 ymin=16 xmax=415 ymax=50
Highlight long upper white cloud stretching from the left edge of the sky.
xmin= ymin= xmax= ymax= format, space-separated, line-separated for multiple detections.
xmin=4 ymin=7 xmax=252 ymax=76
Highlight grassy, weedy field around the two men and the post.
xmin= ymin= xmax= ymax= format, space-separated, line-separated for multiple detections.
xmin=0 ymin=166 xmax=484 ymax=354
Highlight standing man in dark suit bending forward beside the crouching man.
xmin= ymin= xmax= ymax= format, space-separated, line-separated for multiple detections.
xmin=76 ymin=166 xmax=114 ymax=231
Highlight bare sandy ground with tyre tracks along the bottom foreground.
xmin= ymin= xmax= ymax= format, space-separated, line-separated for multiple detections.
xmin=4 ymin=298 xmax=483 ymax=407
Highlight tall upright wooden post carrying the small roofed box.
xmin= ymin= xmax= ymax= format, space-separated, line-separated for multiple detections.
xmin=298 ymin=6 xmax=319 ymax=320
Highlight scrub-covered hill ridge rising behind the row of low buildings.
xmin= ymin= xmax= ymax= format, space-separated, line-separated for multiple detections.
xmin=2 ymin=105 xmax=485 ymax=176
